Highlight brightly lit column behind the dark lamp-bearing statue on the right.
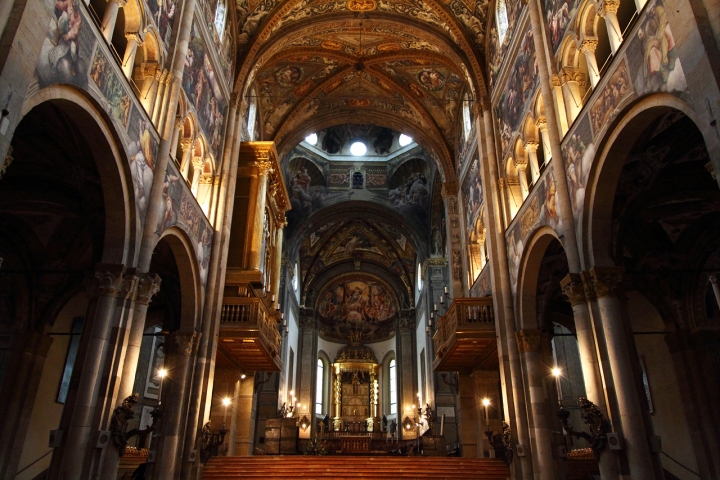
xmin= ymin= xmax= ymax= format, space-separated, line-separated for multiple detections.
xmin=560 ymin=273 xmax=619 ymax=480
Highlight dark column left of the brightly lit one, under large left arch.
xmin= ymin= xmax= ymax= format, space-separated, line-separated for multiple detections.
xmin=59 ymin=265 xmax=125 ymax=479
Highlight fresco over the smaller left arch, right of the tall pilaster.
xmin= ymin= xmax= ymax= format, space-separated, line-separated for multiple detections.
xmin=157 ymin=162 xmax=213 ymax=285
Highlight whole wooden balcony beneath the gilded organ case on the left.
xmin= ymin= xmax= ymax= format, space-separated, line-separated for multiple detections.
xmin=217 ymin=297 xmax=282 ymax=372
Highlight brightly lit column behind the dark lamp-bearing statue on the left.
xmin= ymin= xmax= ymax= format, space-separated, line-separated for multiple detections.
xmin=100 ymin=273 xmax=160 ymax=478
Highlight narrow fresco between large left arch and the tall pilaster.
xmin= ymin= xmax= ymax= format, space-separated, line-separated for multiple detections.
xmin=127 ymin=108 xmax=159 ymax=219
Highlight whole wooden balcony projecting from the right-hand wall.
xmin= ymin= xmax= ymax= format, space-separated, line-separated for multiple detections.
xmin=433 ymin=297 xmax=498 ymax=372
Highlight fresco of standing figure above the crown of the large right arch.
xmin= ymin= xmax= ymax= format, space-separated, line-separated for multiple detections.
xmin=627 ymin=0 xmax=687 ymax=95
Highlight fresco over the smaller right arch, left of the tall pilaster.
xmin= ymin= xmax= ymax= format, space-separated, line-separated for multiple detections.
xmin=505 ymin=167 xmax=562 ymax=293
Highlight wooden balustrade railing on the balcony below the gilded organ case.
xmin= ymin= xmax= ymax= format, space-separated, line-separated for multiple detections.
xmin=220 ymin=297 xmax=282 ymax=357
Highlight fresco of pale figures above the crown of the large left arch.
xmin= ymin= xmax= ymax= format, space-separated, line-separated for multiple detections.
xmin=35 ymin=0 xmax=95 ymax=88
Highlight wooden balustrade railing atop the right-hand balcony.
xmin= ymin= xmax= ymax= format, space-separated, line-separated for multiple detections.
xmin=433 ymin=297 xmax=495 ymax=357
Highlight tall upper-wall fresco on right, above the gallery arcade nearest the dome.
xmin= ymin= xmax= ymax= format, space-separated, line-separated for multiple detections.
xmin=495 ymin=26 xmax=539 ymax=154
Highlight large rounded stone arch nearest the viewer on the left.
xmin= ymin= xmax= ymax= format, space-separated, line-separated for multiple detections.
xmin=18 ymin=85 xmax=141 ymax=264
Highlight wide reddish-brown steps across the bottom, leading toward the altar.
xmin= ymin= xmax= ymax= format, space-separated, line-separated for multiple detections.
xmin=203 ymin=455 xmax=510 ymax=480
